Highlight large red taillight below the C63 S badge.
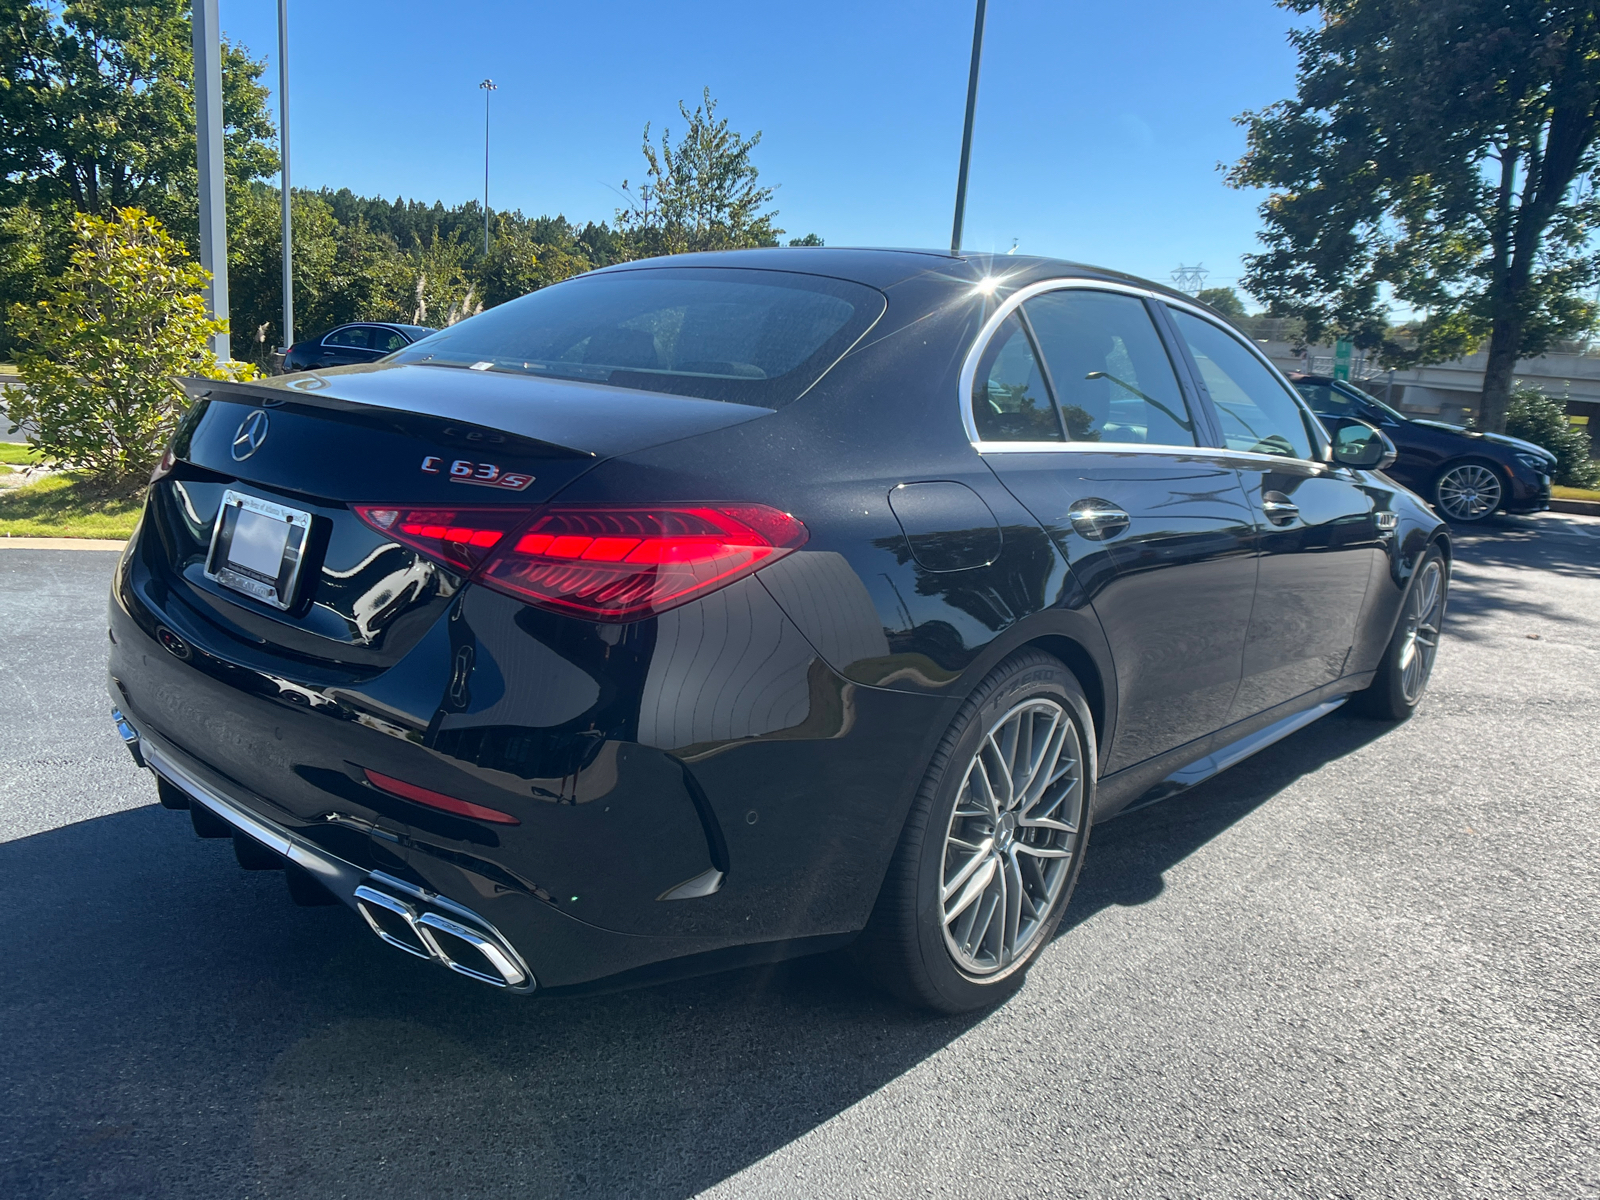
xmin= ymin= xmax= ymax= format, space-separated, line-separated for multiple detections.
xmin=478 ymin=504 xmax=806 ymax=621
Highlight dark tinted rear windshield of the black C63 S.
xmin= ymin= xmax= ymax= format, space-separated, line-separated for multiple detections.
xmin=390 ymin=267 xmax=885 ymax=408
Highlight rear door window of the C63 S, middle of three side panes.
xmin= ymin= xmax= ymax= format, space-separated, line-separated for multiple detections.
xmin=1022 ymin=288 xmax=1195 ymax=446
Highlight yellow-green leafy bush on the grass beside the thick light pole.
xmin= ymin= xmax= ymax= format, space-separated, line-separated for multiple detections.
xmin=6 ymin=208 xmax=256 ymax=486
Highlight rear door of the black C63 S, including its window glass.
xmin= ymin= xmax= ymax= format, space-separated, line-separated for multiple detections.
xmin=971 ymin=286 xmax=1256 ymax=773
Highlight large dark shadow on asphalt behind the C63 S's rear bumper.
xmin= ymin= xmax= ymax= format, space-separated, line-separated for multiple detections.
xmin=0 ymin=806 xmax=982 ymax=1200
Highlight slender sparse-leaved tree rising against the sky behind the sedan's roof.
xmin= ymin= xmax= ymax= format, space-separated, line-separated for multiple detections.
xmin=616 ymin=88 xmax=784 ymax=258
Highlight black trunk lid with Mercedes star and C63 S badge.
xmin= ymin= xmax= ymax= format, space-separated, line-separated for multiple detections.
xmin=142 ymin=363 xmax=771 ymax=678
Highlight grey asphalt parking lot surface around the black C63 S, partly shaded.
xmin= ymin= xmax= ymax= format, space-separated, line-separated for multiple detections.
xmin=0 ymin=514 xmax=1600 ymax=1200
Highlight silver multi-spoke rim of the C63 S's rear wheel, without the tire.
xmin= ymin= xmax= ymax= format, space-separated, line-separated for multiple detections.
xmin=939 ymin=698 xmax=1083 ymax=974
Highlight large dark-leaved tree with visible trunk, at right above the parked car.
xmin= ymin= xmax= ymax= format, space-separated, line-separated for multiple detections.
xmin=1229 ymin=0 xmax=1600 ymax=430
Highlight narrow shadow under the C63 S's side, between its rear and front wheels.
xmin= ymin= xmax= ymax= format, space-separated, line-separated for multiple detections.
xmin=1056 ymin=710 xmax=1394 ymax=938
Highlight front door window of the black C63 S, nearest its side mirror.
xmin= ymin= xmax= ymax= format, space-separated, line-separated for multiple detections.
xmin=1170 ymin=309 xmax=1310 ymax=459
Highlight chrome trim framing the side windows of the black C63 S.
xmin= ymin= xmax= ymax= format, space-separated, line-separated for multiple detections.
xmin=957 ymin=278 xmax=1331 ymax=467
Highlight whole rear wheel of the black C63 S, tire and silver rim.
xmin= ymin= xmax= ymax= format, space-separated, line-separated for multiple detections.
xmin=856 ymin=651 xmax=1096 ymax=1013
